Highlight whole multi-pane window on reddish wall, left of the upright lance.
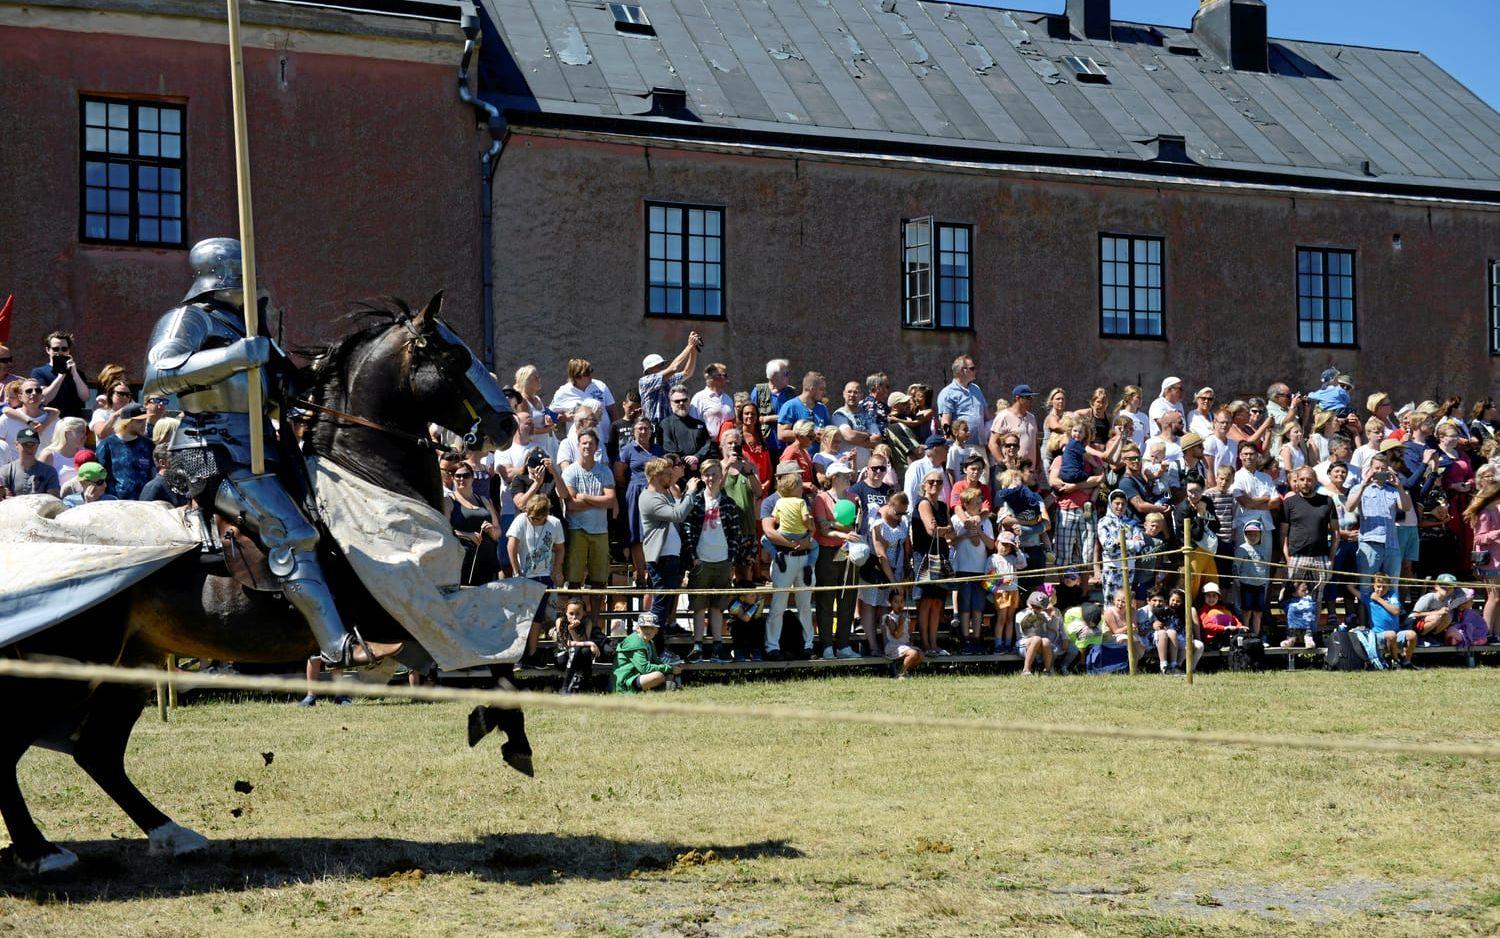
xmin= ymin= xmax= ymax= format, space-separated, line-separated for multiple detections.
xmin=80 ymin=98 xmax=188 ymax=246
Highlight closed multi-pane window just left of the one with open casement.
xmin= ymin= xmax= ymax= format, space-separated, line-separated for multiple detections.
xmin=647 ymin=203 xmax=725 ymax=320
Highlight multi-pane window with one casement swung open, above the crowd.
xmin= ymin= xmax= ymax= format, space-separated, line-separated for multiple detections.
xmin=902 ymin=216 xmax=974 ymax=329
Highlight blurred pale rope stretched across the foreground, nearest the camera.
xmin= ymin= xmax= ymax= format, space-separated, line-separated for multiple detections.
xmin=0 ymin=659 xmax=1500 ymax=761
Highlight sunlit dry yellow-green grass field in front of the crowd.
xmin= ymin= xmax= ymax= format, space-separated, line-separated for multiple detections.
xmin=0 ymin=668 xmax=1500 ymax=936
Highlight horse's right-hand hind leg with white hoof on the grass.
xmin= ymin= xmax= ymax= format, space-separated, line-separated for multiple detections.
xmin=74 ymin=686 xmax=209 ymax=857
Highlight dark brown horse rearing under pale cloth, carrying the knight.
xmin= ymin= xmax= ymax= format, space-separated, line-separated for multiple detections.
xmin=0 ymin=293 xmax=530 ymax=872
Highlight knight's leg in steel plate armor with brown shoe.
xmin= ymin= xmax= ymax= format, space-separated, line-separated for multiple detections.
xmin=215 ymin=468 xmax=401 ymax=668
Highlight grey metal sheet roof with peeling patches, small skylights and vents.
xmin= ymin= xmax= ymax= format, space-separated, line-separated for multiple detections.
xmin=482 ymin=0 xmax=1500 ymax=197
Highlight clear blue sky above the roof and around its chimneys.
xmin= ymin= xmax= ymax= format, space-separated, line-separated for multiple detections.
xmin=990 ymin=0 xmax=1500 ymax=110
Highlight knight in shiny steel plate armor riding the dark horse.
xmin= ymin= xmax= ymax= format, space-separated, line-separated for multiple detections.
xmin=144 ymin=237 xmax=401 ymax=668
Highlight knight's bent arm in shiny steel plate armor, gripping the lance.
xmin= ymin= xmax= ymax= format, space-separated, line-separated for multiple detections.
xmin=144 ymin=306 xmax=272 ymax=396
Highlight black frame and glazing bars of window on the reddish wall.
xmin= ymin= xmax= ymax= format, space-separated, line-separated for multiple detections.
xmin=78 ymin=95 xmax=189 ymax=251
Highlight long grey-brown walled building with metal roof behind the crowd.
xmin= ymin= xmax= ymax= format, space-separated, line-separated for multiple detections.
xmin=480 ymin=0 xmax=1500 ymax=396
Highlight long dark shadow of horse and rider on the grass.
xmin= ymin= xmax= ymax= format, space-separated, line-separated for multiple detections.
xmin=0 ymin=833 xmax=803 ymax=903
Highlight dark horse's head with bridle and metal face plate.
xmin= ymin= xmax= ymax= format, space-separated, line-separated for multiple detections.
xmin=401 ymin=290 xmax=516 ymax=450
